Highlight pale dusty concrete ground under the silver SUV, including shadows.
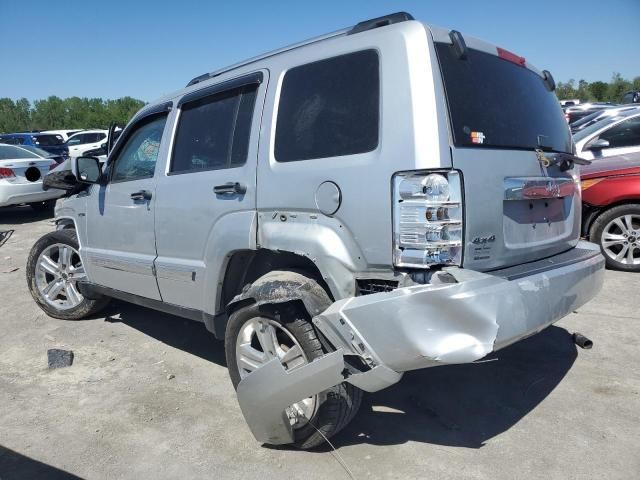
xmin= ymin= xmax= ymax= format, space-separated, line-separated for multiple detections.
xmin=0 ymin=207 xmax=640 ymax=480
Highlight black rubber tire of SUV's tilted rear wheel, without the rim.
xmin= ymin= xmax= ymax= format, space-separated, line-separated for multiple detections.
xmin=225 ymin=278 xmax=362 ymax=450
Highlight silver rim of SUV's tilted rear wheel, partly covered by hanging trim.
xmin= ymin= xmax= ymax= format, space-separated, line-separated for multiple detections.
xmin=236 ymin=317 xmax=319 ymax=429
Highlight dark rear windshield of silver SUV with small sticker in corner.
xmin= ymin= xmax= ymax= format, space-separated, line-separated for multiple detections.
xmin=436 ymin=43 xmax=572 ymax=152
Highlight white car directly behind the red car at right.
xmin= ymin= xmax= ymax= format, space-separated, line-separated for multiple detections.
xmin=573 ymin=109 xmax=640 ymax=160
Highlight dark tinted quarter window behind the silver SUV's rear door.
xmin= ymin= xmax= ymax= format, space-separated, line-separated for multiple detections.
xmin=275 ymin=50 xmax=380 ymax=162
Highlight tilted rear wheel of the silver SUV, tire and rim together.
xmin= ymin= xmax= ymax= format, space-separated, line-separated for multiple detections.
xmin=225 ymin=280 xmax=362 ymax=449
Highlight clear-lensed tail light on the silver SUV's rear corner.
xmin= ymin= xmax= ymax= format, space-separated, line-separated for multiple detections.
xmin=393 ymin=171 xmax=463 ymax=268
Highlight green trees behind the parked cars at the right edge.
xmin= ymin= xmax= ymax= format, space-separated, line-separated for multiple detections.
xmin=556 ymin=73 xmax=640 ymax=103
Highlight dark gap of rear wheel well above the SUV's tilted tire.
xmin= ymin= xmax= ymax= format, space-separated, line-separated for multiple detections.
xmin=219 ymin=249 xmax=333 ymax=311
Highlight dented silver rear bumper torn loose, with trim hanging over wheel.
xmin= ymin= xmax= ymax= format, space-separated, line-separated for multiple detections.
xmin=238 ymin=242 xmax=604 ymax=444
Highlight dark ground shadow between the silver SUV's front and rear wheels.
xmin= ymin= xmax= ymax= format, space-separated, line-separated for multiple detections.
xmin=101 ymin=300 xmax=226 ymax=367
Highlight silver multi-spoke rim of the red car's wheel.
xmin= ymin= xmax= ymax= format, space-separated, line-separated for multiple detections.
xmin=600 ymin=215 xmax=640 ymax=265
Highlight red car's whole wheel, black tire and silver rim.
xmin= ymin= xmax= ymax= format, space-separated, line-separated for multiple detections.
xmin=589 ymin=203 xmax=640 ymax=272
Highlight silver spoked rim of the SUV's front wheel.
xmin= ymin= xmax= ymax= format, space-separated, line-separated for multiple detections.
xmin=35 ymin=243 xmax=86 ymax=310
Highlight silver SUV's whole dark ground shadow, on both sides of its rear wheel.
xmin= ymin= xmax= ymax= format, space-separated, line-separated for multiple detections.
xmin=100 ymin=302 xmax=577 ymax=451
